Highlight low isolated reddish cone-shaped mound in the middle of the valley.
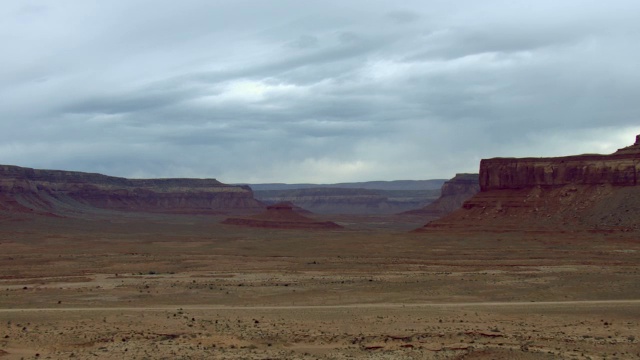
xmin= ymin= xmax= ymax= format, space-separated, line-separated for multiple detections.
xmin=222 ymin=202 xmax=342 ymax=230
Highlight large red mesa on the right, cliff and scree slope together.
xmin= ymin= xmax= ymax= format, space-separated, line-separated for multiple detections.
xmin=424 ymin=136 xmax=640 ymax=231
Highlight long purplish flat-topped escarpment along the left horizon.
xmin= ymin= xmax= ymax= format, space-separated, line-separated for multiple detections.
xmin=0 ymin=165 xmax=264 ymax=216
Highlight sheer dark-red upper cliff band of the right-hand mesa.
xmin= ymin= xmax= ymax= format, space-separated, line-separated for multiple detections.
xmin=480 ymin=135 xmax=640 ymax=191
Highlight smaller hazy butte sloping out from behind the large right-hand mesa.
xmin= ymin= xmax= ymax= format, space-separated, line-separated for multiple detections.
xmin=402 ymin=174 xmax=480 ymax=218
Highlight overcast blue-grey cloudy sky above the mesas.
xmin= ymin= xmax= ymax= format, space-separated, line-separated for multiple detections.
xmin=0 ymin=0 xmax=640 ymax=183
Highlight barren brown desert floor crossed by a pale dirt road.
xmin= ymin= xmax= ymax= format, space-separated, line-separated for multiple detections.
xmin=0 ymin=215 xmax=640 ymax=360
